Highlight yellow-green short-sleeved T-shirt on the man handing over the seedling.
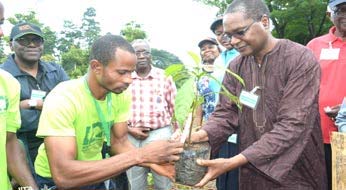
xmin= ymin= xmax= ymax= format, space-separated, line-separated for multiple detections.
xmin=35 ymin=78 xmax=131 ymax=177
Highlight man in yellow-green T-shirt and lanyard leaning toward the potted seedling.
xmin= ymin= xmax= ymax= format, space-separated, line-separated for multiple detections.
xmin=35 ymin=34 xmax=183 ymax=189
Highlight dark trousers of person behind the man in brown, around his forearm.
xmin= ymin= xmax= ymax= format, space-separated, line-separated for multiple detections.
xmin=215 ymin=142 xmax=239 ymax=190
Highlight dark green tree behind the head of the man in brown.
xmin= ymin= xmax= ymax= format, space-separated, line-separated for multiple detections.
xmin=195 ymin=0 xmax=332 ymax=45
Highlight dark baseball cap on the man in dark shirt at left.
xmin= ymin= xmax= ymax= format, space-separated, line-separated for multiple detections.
xmin=10 ymin=22 xmax=43 ymax=41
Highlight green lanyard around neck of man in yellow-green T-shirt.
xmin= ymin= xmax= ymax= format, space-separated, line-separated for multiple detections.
xmin=84 ymin=77 xmax=112 ymax=146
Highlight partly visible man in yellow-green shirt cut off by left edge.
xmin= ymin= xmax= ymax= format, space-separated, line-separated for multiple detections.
xmin=0 ymin=2 xmax=37 ymax=190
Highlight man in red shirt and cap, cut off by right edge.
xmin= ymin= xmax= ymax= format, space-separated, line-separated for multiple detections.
xmin=307 ymin=0 xmax=346 ymax=189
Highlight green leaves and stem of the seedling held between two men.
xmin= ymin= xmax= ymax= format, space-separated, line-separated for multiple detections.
xmin=165 ymin=52 xmax=245 ymax=144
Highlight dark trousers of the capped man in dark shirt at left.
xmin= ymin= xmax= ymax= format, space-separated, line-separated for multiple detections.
xmin=17 ymin=130 xmax=43 ymax=181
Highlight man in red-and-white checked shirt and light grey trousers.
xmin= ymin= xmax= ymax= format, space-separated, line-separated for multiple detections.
xmin=127 ymin=39 xmax=178 ymax=190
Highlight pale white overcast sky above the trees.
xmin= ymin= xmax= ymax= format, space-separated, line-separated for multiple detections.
xmin=1 ymin=0 xmax=218 ymax=63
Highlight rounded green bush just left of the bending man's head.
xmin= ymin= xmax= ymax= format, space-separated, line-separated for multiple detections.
xmin=61 ymin=47 xmax=89 ymax=78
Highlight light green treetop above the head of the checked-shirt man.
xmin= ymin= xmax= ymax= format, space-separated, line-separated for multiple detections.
xmin=120 ymin=21 xmax=147 ymax=42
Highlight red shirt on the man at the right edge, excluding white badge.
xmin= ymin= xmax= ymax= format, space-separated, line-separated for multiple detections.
xmin=307 ymin=26 xmax=346 ymax=144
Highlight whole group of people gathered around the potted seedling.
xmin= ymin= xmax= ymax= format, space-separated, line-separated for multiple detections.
xmin=0 ymin=0 xmax=346 ymax=190
